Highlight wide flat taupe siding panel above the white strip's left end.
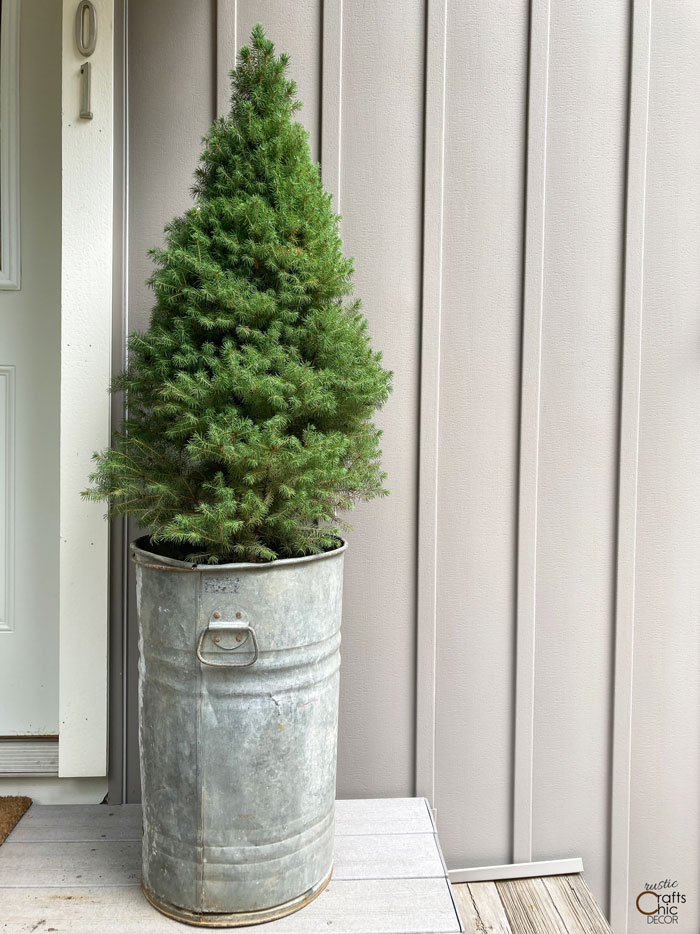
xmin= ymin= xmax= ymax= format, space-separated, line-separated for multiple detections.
xmin=436 ymin=0 xmax=528 ymax=866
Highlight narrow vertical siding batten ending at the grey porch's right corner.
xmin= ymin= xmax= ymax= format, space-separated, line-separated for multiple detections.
xmin=416 ymin=0 xmax=447 ymax=806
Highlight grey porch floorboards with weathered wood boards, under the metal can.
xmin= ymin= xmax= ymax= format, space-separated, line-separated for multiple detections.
xmin=0 ymin=798 xmax=611 ymax=934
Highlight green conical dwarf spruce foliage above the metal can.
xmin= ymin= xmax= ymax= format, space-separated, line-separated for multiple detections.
xmin=85 ymin=25 xmax=391 ymax=563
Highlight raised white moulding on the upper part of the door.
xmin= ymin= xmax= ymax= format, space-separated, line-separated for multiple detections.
xmin=0 ymin=0 xmax=20 ymax=289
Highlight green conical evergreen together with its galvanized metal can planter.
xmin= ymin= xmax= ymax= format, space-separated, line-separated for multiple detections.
xmin=85 ymin=25 xmax=390 ymax=926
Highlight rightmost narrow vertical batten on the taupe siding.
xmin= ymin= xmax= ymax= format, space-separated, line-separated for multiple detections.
xmin=610 ymin=0 xmax=651 ymax=932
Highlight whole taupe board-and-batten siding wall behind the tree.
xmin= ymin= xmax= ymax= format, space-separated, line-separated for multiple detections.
xmin=124 ymin=0 xmax=700 ymax=934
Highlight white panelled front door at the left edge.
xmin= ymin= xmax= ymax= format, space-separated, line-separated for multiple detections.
xmin=0 ymin=0 xmax=62 ymax=744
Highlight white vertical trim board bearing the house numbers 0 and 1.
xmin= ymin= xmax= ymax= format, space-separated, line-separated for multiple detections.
xmin=58 ymin=0 xmax=114 ymax=777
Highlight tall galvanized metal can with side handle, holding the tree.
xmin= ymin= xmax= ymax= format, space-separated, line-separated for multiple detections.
xmin=132 ymin=539 xmax=347 ymax=927
